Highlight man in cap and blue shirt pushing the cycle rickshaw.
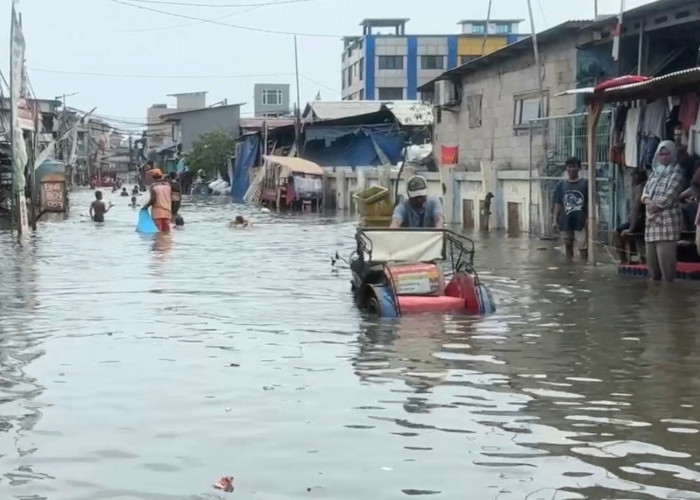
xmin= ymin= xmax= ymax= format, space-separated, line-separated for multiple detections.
xmin=389 ymin=175 xmax=443 ymax=229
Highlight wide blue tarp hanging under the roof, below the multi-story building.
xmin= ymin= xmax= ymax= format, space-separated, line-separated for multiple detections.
xmin=303 ymin=124 xmax=405 ymax=167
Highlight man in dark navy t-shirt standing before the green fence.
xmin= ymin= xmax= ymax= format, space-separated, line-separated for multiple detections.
xmin=553 ymin=157 xmax=588 ymax=259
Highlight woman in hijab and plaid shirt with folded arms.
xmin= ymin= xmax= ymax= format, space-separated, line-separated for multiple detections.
xmin=642 ymin=141 xmax=684 ymax=282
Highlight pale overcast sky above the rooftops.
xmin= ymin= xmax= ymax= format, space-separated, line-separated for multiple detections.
xmin=0 ymin=0 xmax=649 ymax=131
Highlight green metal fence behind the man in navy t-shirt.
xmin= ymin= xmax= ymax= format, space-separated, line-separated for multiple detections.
xmin=529 ymin=111 xmax=626 ymax=243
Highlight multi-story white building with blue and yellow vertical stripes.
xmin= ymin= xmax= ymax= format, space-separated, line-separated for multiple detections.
xmin=342 ymin=19 xmax=523 ymax=101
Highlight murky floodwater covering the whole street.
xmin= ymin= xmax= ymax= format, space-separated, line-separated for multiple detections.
xmin=0 ymin=191 xmax=700 ymax=500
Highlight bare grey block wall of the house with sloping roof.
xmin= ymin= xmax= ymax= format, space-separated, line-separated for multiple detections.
xmin=434 ymin=39 xmax=576 ymax=176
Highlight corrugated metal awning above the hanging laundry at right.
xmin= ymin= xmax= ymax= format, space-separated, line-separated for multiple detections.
xmin=557 ymin=67 xmax=700 ymax=102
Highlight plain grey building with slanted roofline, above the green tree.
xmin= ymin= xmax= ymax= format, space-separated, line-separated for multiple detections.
xmin=161 ymin=104 xmax=241 ymax=152
